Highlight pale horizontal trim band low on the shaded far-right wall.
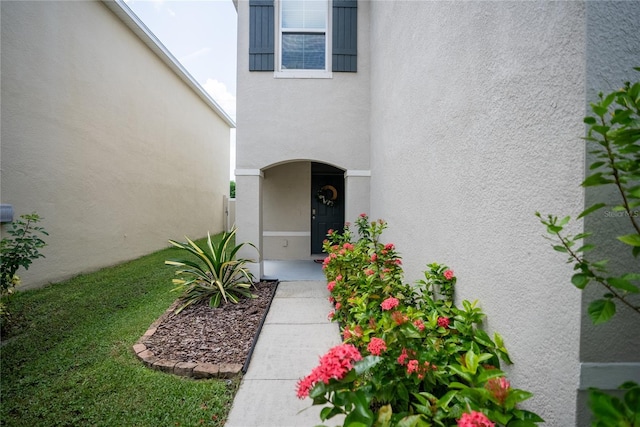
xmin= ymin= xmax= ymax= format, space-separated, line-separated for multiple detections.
xmin=580 ymin=362 xmax=640 ymax=390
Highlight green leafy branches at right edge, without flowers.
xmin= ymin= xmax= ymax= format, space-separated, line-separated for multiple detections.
xmin=536 ymin=68 xmax=640 ymax=324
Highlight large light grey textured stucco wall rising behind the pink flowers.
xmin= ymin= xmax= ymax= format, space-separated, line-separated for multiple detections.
xmin=371 ymin=1 xmax=585 ymax=426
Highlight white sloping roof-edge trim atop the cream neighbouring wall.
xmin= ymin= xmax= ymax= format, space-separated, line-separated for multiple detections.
xmin=101 ymin=0 xmax=236 ymax=128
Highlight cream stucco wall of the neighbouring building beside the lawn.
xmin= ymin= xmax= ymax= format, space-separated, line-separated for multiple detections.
xmin=0 ymin=1 xmax=229 ymax=287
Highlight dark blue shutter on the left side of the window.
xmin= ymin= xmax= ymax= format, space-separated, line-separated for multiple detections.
xmin=249 ymin=0 xmax=275 ymax=71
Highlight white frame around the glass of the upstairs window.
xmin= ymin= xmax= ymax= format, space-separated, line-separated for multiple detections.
xmin=274 ymin=0 xmax=333 ymax=79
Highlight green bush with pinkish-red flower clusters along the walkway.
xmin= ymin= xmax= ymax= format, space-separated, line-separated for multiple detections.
xmin=298 ymin=214 xmax=542 ymax=427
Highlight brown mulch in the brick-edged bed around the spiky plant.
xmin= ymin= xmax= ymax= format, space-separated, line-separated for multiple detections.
xmin=143 ymin=282 xmax=276 ymax=365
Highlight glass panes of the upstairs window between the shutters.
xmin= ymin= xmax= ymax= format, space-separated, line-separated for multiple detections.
xmin=280 ymin=0 xmax=329 ymax=70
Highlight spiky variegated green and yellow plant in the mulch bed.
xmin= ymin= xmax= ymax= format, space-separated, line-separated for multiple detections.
xmin=165 ymin=227 xmax=257 ymax=314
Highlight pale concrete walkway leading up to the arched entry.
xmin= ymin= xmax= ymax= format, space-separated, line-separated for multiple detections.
xmin=225 ymin=264 xmax=342 ymax=427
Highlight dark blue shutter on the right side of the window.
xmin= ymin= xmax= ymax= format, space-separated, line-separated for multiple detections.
xmin=331 ymin=0 xmax=358 ymax=73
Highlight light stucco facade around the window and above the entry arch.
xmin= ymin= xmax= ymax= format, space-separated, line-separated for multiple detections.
xmin=236 ymin=0 xmax=370 ymax=169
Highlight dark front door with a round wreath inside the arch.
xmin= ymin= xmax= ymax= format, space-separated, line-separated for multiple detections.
xmin=311 ymin=164 xmax=344 ymax=254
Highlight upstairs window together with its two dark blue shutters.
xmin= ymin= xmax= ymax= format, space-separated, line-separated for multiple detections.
xmin=249 ymin=0 xmax=358 ymax=77
